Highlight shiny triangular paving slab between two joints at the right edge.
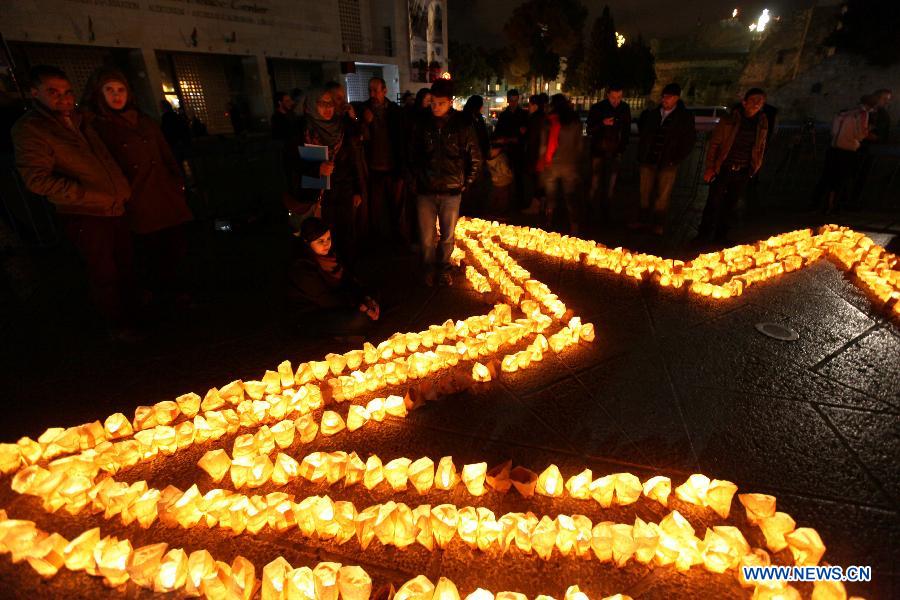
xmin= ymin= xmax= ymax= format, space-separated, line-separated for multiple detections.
xmin=818 ymin=324 xmax=900 ymax=408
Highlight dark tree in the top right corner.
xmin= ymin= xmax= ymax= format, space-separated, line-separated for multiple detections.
xmin=826 ymin=0 xmax=900 ymax=67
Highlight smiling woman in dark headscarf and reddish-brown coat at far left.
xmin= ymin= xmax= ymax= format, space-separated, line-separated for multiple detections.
xmin=82 ymin=67 xmax=193 ymax=302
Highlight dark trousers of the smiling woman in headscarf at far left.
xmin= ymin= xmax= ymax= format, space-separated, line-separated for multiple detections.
xmin=134 ymin=225 xmax=188 ymax=297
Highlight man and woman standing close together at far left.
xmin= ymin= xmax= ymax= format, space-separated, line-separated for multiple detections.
xmin=12 ymin=66 xmax=193 ymax=342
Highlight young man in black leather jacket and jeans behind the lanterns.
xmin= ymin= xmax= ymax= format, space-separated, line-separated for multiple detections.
xmin=408 ymin=79 xmax=482 ymax=286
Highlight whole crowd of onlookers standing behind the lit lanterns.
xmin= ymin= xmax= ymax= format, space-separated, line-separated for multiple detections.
xmin=12 ymin=61 xmax=891 ymax=340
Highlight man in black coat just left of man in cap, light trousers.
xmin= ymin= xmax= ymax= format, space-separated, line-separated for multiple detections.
xmin=587 ymin=85 xmax=631 ymax=220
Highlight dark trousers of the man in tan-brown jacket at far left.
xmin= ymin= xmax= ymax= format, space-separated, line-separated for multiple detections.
xmin=62 ymin=215 xmax=135 ymax=327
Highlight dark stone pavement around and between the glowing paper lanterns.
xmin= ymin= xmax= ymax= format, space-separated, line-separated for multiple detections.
xmin=0 ymin=209 xmax=900 ymax=598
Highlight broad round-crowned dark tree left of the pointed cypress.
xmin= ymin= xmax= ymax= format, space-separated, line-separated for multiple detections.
xmin=503 ymin=0 xmax=587 ymax=91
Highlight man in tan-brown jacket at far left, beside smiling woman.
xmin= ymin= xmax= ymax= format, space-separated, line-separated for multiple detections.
xmin=12 ymin=65 xmax=133 ymax=337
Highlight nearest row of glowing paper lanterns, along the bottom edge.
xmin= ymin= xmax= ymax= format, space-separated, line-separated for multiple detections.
xmin=0 ymin=510 xmax=676 ymax=600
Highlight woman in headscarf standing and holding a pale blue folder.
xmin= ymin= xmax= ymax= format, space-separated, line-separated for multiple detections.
xmin=288 ymin=89 xmax=363 ymax=261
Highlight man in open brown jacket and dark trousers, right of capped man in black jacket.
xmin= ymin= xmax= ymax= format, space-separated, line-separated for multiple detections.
xmin=697 ymin=88 xmax=769 ymax=243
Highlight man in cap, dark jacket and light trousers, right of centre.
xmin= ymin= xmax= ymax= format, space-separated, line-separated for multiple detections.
xmin=631 ymin=83 xmax=697 ymax=235
